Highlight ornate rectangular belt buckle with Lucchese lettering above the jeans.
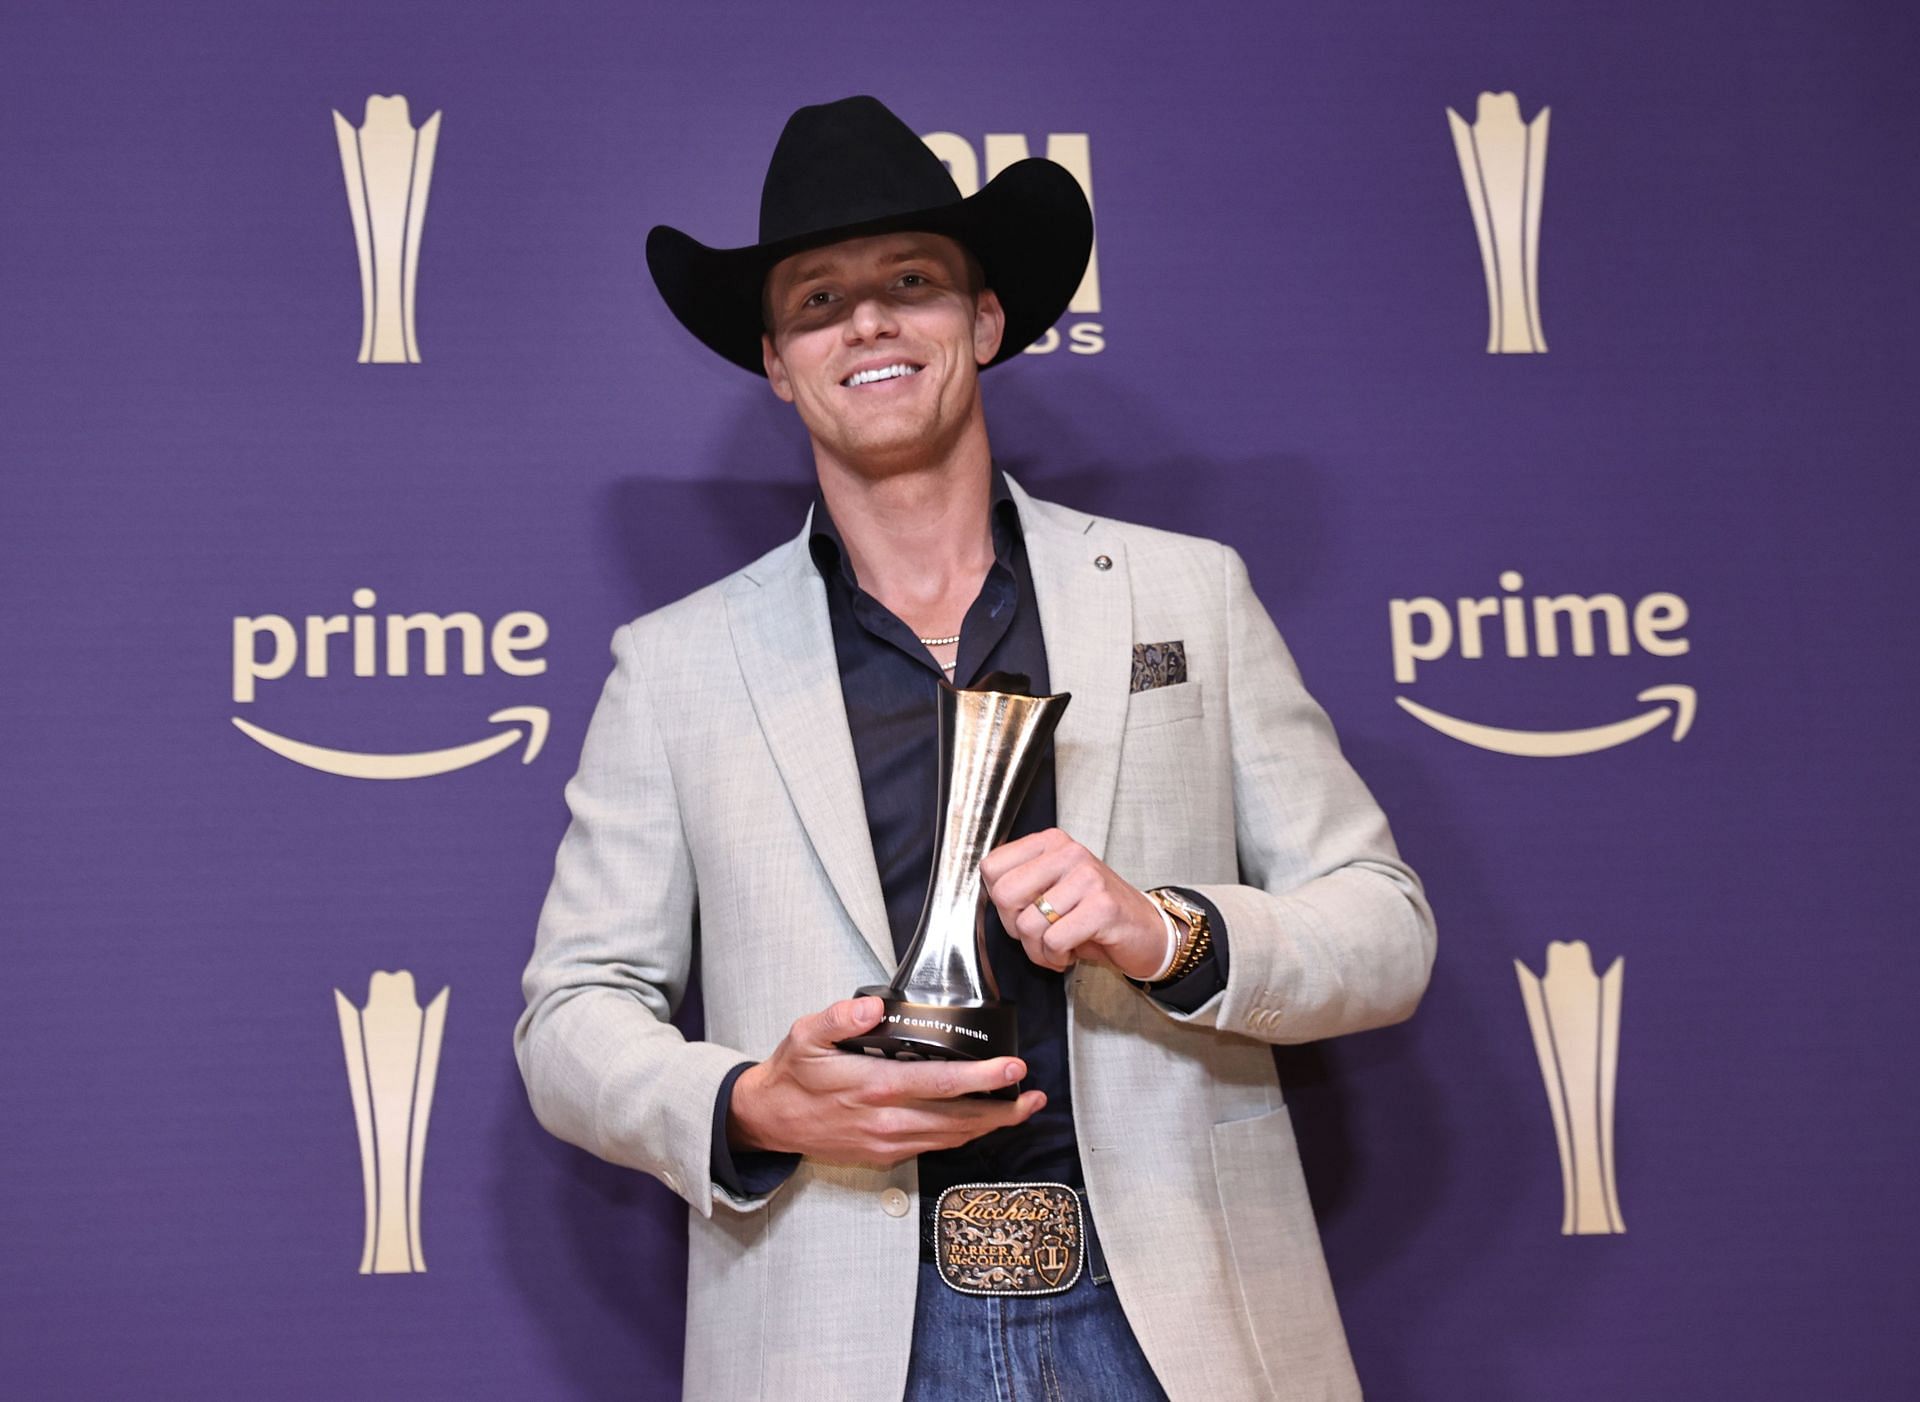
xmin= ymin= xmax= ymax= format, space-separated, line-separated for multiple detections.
xmin=933 ymin=1183 xmax=1087 ymax=1294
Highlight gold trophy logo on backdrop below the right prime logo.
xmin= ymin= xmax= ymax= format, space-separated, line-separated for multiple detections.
xmin=1513 ymin=939 xmax=1626 ymax=1237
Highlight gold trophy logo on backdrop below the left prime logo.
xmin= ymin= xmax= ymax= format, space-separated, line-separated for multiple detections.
xmin=334 ymin=970 xmax=451 ymax=1275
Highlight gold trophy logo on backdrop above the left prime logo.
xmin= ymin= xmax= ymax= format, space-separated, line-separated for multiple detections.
xmin=334 ymin=94 xmax=440 ymax=365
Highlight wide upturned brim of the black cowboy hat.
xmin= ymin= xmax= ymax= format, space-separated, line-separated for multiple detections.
xmin=647 ymin=157 xmax=1092 ymax=375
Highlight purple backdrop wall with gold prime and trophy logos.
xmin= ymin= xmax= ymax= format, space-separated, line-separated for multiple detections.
xmin=0 ymin=0 xmax=1920 ymax=1402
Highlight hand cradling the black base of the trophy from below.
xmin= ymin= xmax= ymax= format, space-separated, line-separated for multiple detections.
xmin=726 ymin=997 xmax=1046 ymax=1168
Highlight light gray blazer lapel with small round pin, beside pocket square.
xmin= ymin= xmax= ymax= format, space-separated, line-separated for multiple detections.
xmin=1006 ymin=478 xmax=1133 ymax=858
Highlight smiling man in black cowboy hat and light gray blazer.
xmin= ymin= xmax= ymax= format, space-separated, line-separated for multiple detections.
xmin=516 ymin=98 xmax=1432 ymax=1402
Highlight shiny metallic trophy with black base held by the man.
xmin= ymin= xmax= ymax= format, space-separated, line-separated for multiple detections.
xmin=839 ymin=672 xmax=1073 ymax=1060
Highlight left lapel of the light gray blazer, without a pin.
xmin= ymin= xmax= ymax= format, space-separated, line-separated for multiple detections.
xmin=726 ymin=513 xmax=899 ymax=972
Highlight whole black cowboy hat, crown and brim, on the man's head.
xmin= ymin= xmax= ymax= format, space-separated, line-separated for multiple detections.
xmin=647 ymin=98 xmax=1092 ymax=375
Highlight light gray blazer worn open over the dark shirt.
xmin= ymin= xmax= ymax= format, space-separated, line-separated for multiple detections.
xmin=515 ymin=472 xmax=1434 ymax=1402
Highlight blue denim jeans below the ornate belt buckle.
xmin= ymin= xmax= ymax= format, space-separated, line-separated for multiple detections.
xmin=904 ymin=1262 xmax=1167 ymax=1402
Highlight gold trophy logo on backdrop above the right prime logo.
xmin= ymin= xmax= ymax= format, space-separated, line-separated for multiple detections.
xmin=1446 ymin=92 xmax=1551 ymax=355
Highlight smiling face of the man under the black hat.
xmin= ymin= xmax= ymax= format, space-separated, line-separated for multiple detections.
xmin=760 ymin=232 xmax=1006 ymax=476
